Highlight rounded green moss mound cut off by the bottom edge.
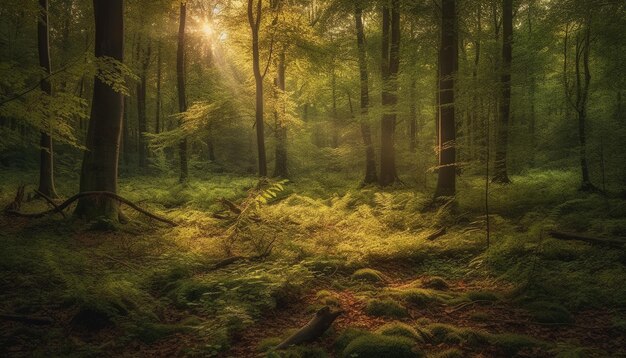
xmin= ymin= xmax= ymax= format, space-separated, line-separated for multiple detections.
xmin=342 ymin=334 xmax=424 ymax=358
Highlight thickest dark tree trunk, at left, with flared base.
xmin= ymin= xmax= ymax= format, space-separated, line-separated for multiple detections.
xmin=75 ymin=0 xmax=124 ymax=221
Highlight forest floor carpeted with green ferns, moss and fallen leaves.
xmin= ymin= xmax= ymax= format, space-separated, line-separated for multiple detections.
xmin=0 ymin=171 xmax=626 ymax=357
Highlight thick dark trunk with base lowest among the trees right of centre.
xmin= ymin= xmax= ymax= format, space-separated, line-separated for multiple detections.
xmin=435 ymin=0 xmax=458 ymax=197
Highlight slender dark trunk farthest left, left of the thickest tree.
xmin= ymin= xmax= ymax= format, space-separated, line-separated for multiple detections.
xmin=37 ymin=0 xmax=57 ymax=197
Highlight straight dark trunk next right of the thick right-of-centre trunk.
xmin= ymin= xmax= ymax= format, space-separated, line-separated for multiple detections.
xmin=493 ymin=0 xmax=513 ymax=184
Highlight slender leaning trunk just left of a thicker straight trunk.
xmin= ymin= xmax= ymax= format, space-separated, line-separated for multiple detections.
xmin=354 ymin=3 xmax=378 ymax=185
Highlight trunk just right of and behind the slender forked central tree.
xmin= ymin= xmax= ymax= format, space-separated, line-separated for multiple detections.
xmin=274 ymin=50 xmax=289 ymax=178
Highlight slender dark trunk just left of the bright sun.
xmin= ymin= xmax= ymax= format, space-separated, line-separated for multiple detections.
xmin=176 ymin=1 xmax=189 ymax=183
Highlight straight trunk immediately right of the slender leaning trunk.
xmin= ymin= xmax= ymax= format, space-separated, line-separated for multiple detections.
xmin=379 ymin=0 xmax=400 ymax=186
